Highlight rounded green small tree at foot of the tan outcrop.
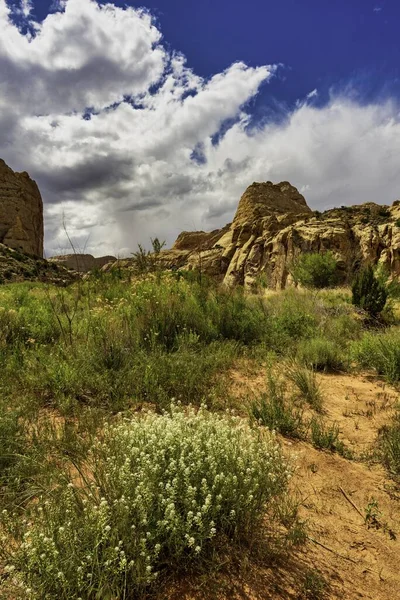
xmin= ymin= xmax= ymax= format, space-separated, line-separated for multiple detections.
xmin=291 ymin=252 xmax=337 ymax=289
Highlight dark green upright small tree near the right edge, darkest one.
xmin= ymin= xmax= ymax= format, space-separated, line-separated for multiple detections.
xmin=352 ymin=266 xmax=388 ymax=317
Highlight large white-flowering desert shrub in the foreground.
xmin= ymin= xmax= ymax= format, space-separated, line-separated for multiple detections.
xmin=3 ymin=408 xmax=290 ymax=600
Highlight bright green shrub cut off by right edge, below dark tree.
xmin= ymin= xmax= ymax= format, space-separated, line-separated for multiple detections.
xmin=352 ymin=328 xmax=400 ymax=383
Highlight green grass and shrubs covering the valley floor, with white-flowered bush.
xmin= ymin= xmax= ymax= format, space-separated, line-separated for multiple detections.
xmin=0 ymin=252 xmax=400 ymax=600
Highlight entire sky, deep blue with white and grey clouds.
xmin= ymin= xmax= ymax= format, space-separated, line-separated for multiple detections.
xmin=0 ymin=0 xmax=400 ymax=254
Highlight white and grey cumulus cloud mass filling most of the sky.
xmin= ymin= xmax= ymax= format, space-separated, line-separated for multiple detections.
xmin=0 ymin=0 xmax=400 ymax=255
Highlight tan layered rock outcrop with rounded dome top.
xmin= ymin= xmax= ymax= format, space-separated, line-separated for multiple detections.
xmin=155 ymin=182 xmax=400 ymax=289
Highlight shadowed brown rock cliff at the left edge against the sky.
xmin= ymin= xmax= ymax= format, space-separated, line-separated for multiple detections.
xmin=0 ymin=159 xmax=43 ymax=257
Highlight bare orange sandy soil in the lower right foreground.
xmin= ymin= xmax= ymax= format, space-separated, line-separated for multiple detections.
xmin=164 ymin=366 xmax=400 ymax=600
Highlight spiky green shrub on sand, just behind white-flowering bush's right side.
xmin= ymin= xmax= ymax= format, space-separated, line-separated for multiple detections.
xmin=251 ymin=373 xmax=304 ymax=438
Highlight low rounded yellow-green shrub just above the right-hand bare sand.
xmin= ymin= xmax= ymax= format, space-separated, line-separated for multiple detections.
xmin=297 ymin=337 xmax=346 ymax=372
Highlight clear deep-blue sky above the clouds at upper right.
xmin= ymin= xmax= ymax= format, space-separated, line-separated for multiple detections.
xmin=25 ymin=0 xmax=400 ymax=106
